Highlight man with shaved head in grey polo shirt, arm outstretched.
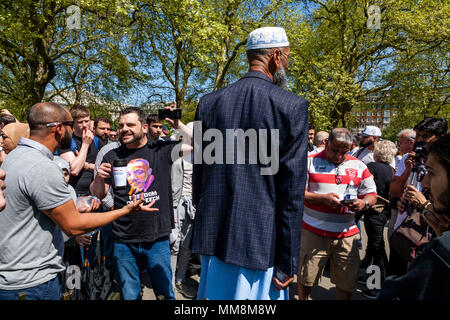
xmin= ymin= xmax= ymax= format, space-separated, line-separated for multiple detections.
xmin=0 ymin=102 xmax=158 ymax=300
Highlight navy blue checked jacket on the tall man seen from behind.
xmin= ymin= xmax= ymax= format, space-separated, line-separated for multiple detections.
xmin=192 ymin=72 xmax=308 ymax=275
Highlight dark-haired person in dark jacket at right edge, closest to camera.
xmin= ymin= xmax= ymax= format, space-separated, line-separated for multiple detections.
xmin=377 ymin=134 xmax=450 ymax=301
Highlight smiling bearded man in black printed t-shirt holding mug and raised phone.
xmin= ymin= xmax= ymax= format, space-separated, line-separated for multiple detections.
xmin=91 ymin=107 xmax=192 ymax=300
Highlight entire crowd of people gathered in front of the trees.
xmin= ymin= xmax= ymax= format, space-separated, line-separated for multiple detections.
xmin=0 ymin=27 xmax=450 ymax=300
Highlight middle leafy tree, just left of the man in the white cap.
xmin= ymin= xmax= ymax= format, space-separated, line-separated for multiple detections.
xmin=128 ymin=0 xmax=289 ymax=108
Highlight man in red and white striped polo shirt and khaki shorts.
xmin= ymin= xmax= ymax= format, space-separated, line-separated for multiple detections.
xmin=297 ymin=128 xmax=377 ymax=300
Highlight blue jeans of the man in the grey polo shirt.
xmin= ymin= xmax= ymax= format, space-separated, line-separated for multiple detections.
xmin=0 ymin=276 xmax=61 ymax=300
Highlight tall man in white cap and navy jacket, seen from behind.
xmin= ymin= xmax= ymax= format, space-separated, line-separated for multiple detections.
xmin=192 ymin=27 xmax=308 ymax=300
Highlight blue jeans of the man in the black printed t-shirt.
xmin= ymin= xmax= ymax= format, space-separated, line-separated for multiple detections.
xmin=114 ymin=237 xmax=175 ymax=300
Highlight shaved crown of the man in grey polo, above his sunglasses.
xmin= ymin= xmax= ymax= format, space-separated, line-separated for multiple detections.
xmin=27 ymin=102 xmax=71 ymax=131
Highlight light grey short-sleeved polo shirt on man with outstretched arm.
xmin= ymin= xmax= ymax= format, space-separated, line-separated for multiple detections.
xmin=0 ymin=138 xmax=72 ymax=290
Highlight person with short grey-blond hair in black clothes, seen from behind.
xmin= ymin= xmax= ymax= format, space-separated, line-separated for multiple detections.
xmin=361 ymin=140 xmax=397 ymax=298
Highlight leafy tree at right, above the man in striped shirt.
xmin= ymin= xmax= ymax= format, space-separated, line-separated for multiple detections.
xmin=289 ymin=0 xmax=449 ymax=129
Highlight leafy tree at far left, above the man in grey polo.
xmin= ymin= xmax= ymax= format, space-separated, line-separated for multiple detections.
xmin=0 ymin=0 xmax=139 ymax=120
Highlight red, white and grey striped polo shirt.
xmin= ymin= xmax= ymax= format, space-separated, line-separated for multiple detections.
xmin=302 ymin=150 xmax=377 ymax=238
